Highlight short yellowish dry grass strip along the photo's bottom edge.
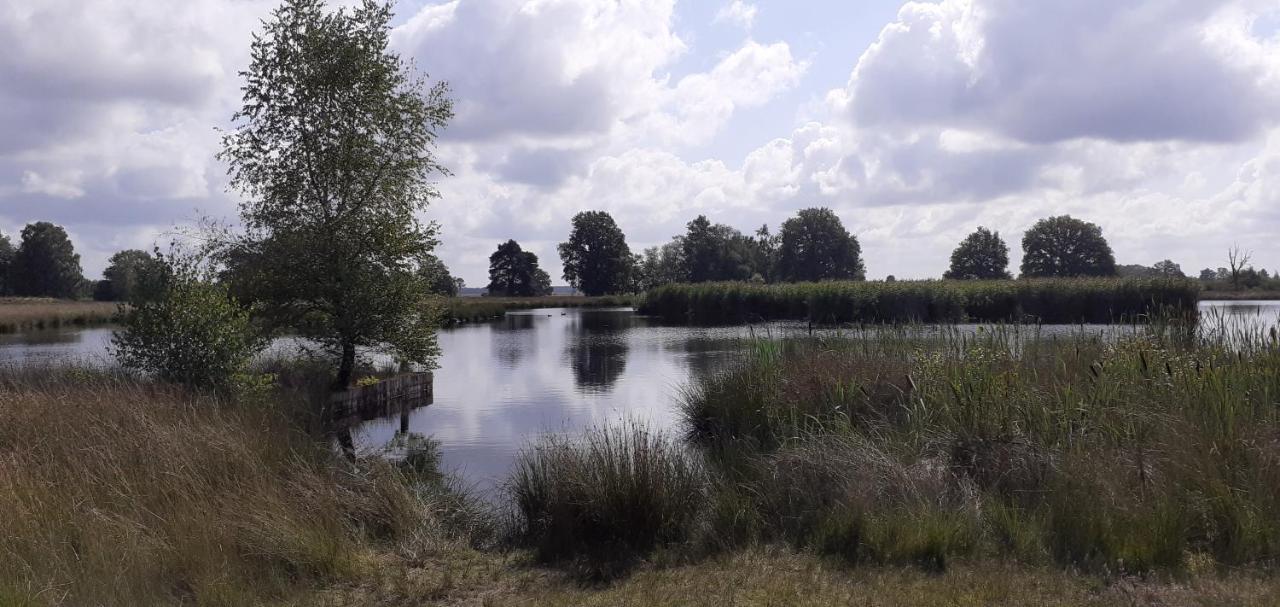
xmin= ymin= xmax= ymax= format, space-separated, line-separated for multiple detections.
xmin=302 ymin=548 xmax=1280 ymax=607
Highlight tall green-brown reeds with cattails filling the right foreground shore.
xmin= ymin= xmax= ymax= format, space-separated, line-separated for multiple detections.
xmin=684 ymin=320 xmax=1280 ymax=572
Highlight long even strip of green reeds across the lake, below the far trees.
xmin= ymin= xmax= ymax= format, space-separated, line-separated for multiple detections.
xmin=639 ymin=279 xmax=1199 ymax=324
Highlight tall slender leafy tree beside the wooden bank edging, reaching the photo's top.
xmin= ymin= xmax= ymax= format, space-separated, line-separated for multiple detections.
xmin=220 ymin=0 xmax=453 ymax=389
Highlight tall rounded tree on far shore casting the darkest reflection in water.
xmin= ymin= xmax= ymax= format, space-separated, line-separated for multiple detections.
xmin=558 ymin=211 xmax=635 ymax=296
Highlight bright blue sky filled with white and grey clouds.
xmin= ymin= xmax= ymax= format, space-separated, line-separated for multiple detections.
xmin=0 ymin=0 xmax=1280 ymax=287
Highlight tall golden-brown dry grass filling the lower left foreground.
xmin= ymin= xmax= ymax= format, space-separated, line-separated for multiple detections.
xmin=0 ymin=369 xmax=473 ymax=606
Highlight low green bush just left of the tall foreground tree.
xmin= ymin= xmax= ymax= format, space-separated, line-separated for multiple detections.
xmin=111 ymin=248 xmax=266 ymax=392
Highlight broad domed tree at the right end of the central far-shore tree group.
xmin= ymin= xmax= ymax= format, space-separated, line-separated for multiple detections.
xmin=777 ymin=207 xmax=867 ymax=282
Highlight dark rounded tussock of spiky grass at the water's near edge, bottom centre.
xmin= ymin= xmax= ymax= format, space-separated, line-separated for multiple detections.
xmin=509 ymin=424 xmax=707 ymax=575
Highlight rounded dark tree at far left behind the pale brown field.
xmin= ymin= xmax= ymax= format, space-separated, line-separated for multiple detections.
xmin=9 ymin=222 xmax=84 ymax=298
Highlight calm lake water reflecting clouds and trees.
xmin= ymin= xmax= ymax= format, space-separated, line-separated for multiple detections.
xmin=0 ymin=301 xmax=1280 ymax=490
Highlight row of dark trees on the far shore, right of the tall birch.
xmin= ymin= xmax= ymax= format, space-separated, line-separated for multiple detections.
xmin=489 ymin=207 xmax=1203 ymax=296
